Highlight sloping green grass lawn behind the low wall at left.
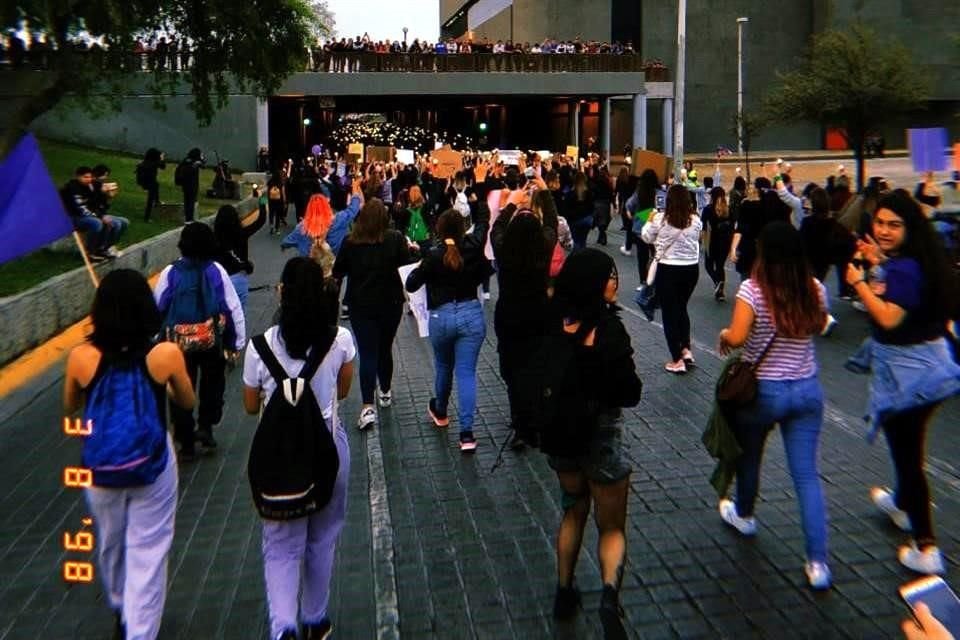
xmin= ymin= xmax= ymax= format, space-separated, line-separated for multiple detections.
xmin=0 ymin=140 xmax=249 ymax=297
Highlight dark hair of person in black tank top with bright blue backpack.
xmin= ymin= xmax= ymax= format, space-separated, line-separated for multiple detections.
xmin=88 ymin=269 xmax=161 ymax=354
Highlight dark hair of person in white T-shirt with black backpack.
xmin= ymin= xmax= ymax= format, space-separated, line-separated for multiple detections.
xmin=280 ymin=256 xmax=338 ymax=360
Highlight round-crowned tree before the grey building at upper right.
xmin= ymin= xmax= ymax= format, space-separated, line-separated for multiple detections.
xmin=764 ymin=24 xmax=929 ymax=190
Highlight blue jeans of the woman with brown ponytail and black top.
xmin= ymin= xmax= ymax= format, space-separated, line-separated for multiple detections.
xmin=430 ymin=300 xmax=487 ymax=433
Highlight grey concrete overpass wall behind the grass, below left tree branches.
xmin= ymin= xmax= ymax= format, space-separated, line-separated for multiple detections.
xmin=30 ymin=95 xmax=257 ymax=169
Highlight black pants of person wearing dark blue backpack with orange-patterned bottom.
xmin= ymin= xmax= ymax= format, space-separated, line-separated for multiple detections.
xmin=170 ymin=349 xmax=226 ymax=451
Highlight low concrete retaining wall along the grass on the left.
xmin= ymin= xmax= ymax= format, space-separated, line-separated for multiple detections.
xmin=0 ymin=198 xmax=256 ymax=366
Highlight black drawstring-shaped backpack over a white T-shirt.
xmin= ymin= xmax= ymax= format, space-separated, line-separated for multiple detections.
xmin=247 ymin=328 xmax=340 ymax=520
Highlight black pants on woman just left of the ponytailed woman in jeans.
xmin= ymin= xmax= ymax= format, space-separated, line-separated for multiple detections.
xmin=350 ymin=304 xmax=403 ymax=404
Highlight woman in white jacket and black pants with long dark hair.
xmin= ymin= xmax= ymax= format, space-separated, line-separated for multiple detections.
xmin=641 ymin=184 xmax=703 ymax=374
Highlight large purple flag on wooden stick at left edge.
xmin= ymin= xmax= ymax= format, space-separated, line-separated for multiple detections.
xmin=0 ymin=133 xmax=73 ymax=264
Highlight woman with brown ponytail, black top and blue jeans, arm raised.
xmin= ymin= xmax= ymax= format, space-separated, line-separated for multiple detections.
xmin=406 ymin=204 xmax=493 ymax=453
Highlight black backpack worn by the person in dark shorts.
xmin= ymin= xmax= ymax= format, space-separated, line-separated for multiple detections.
xmin=516 ymin=329 xmax=598 ymax=457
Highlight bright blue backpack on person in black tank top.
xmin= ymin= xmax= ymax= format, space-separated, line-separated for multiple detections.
xmin=83 ymin=354 xmax=169 ymax=487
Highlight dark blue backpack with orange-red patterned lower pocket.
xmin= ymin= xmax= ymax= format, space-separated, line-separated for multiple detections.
xmin=163 ymin=259 xmax=226 ymax=353
